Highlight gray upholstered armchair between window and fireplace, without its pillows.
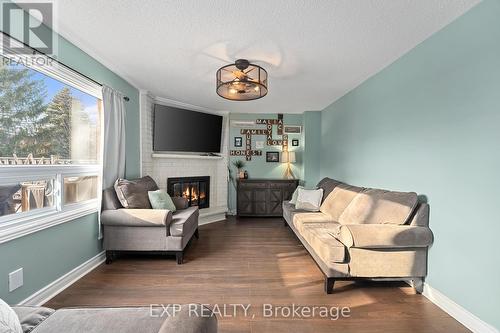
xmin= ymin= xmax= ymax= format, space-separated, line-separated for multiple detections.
xmin=101 ymin=183 xmax=199 ymax=264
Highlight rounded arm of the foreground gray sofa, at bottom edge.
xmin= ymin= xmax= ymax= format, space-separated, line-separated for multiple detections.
xmin=158 ymin=304 xmax=217 ymax=333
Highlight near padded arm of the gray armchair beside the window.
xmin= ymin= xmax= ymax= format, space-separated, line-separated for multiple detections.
xmin=101 ymin=208 xmax=172 ymax=230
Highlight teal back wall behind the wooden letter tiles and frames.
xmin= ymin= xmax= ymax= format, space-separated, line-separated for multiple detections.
xmin=228 ymin=113 xmax=304 ymax=211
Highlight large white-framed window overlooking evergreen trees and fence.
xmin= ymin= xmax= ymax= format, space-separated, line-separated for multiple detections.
xmin=0 ymin=37 xmax=102 ymax=242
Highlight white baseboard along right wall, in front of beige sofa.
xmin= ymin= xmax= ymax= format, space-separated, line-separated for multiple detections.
xmin=409 ymin=283 xmax=499 ymax=333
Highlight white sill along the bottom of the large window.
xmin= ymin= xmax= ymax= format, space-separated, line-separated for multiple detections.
xmin=0 ymin=200 xmax=99 ymax=244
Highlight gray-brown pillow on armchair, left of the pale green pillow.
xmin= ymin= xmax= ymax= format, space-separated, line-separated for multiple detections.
xmin=114 ymin=176 xmax=158 ymax=209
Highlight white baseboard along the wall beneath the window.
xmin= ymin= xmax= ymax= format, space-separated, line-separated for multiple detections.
xmin=18 ymin=251 xmax=106 ymax=306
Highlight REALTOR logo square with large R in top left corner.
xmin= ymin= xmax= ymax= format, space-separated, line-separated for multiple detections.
xmin=0 ymin=0 xmax=56 ymax=55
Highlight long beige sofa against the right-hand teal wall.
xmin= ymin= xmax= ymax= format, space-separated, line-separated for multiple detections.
xmin=283 ymin=178 xmax=433 ymax=294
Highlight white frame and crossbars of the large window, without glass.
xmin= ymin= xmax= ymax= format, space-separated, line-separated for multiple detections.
xmin=0 ymin=33 xmax=104 ymax=244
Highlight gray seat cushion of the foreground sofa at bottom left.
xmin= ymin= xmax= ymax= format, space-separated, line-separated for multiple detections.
xmin=32 ymin=307 xmax=166 ymax=333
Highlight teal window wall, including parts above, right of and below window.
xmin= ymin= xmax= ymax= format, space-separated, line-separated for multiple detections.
xmin=0 ymin=7 xmax=140 ymax=304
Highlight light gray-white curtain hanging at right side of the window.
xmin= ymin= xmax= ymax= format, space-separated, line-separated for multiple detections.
xmin=102 ymin=86 xmax=125 ymax=189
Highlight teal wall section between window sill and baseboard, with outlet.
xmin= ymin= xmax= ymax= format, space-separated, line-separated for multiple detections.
xmin=0 ymin=214 xmax=101 ymax=304
